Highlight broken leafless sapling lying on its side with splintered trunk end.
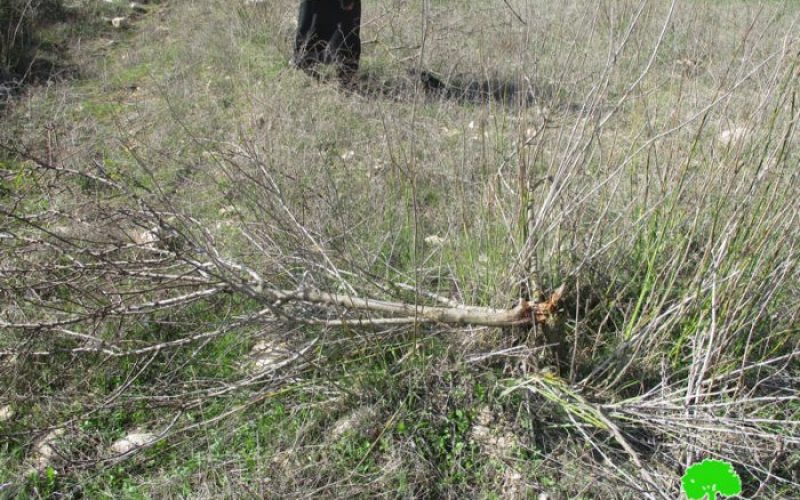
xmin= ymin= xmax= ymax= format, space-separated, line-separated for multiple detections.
xmin=0 ymin=145 xmax=564 ymax=356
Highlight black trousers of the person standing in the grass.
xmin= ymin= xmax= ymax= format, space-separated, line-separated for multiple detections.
xmin=294 ymin=0 xmax=361 ymax=80
